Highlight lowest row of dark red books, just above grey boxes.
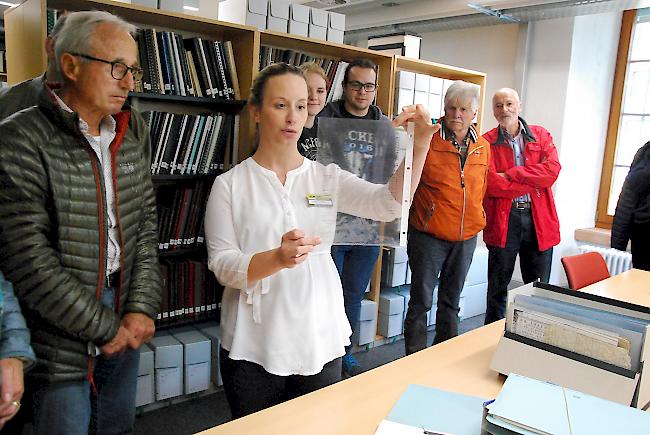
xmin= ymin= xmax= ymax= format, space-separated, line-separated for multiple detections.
xmin=157 ymin=258 xmax=223 ymax=326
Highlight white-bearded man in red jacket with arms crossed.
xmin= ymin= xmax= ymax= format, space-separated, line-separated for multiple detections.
xmin=483 ymin=88 xmax=561 ymax=325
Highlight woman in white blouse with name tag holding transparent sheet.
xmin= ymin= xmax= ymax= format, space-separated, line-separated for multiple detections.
xmin=205 ymin=63 xmax=439 ymax=418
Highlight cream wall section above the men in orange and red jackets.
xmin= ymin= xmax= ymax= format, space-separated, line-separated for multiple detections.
xmin=420 ymin=24 xmax=520 ymax=131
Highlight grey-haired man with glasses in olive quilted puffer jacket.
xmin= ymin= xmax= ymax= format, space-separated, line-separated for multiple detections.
xmin=0 ymin=11 xmax=161 ymax=434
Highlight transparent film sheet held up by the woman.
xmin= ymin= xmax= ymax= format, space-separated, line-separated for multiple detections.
xmin=317 ymin=118 xmax=413 ymax=246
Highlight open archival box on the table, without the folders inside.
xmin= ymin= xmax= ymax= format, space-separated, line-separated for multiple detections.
xmin=490 ymin=283 xmax=650 ymax=409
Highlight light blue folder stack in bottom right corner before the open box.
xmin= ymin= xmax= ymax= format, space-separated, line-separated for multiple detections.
xmin=482 ymin=374 xmax=650 ymax=435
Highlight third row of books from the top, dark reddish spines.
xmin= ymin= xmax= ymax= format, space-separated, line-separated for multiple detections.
xmin=158 ymin=178 xmax=212 ymax=253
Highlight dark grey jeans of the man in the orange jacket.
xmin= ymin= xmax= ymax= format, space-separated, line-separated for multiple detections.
xmin=404 ymin=228 xmax=476 ymax=355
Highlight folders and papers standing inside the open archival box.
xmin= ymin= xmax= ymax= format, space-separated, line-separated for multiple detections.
xmin=508 ymin=294 xmax=650 ymax=372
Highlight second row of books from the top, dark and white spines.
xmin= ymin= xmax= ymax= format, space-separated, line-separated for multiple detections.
xmin=143 ymin=111 xmax=236 ymax=175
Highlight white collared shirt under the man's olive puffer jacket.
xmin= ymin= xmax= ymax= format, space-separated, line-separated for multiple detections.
xmin=53 ymin=92 xmax=121 ymax=276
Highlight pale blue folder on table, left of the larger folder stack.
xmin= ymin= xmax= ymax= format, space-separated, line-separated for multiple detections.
xmin=375 ymin=385 xmax=485 ymax=435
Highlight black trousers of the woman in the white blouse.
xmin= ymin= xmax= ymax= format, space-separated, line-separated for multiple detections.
xmin=219 ymin=348 xmax=341 ymax=418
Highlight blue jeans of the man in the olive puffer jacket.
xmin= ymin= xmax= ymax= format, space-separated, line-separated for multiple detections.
xmin=20 ymin=288 xmax=140 ymax=435
